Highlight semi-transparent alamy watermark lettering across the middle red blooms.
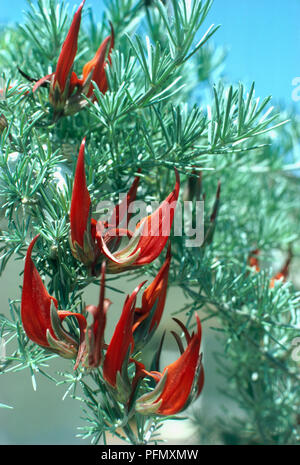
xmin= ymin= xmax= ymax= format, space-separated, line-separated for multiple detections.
xmin=97 ymin=194 xmax=204 ymax=247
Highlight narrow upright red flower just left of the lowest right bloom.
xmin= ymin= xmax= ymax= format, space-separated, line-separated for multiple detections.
xmin=103 ymin=283 xmax=144 ymax=400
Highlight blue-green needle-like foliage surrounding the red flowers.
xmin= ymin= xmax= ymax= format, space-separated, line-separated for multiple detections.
xmin=0 ymin=0 xmax=300 ymax=444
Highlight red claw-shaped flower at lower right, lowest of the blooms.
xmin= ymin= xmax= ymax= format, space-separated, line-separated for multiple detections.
xmin=136 ymin=315 xmax=204 ymax=415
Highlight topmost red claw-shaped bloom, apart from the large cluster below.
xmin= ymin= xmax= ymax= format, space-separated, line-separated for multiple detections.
xmin=31 ymin=0 xmax=114 ymax=116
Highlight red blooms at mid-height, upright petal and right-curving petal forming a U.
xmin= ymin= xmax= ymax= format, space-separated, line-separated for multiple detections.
xmin=70 ymin=139 xmax=180 ymax=274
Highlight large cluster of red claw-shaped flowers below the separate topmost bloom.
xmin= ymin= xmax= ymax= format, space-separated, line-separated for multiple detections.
xmin=21 ymin=160 xmax=204 ymax=415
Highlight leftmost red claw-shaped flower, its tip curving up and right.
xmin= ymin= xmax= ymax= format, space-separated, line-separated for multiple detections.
xmin=21 ymin=235 xmax=86 ymax=361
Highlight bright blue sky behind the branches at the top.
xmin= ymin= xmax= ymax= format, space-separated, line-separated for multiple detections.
xmin=0 ymin=0 xmax=300 ymax=109
